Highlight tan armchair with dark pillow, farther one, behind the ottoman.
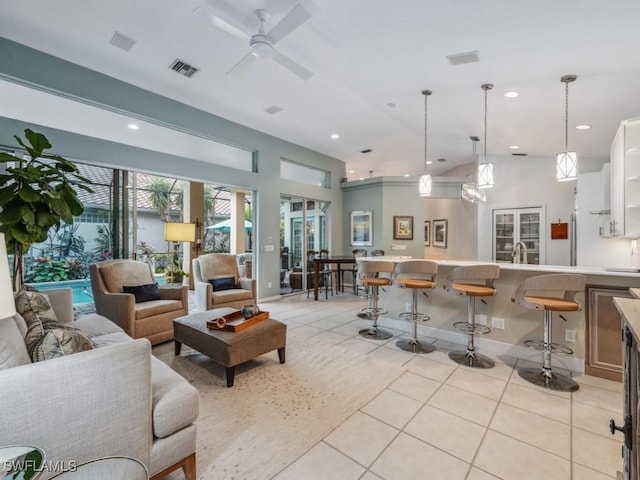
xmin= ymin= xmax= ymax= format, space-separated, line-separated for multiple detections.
xmin=192 ymin=253 xmax=257 ymax=312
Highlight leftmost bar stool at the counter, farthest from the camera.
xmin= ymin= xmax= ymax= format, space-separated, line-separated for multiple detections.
xmin=358 ymin=261 xmax=395 ymax=340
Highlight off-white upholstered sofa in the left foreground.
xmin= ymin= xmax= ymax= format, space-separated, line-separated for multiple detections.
xmin=0 ymin=289 xmax=199 ymax=480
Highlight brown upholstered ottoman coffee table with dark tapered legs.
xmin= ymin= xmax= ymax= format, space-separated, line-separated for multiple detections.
xmin=173 ymin=308 xmax=287 ymax=387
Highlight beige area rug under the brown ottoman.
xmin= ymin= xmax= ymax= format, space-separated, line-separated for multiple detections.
xmin=154 ymin=335 xmax=404 ymax=480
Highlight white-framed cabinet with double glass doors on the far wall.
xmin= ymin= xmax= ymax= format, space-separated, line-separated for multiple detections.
xmin=493 ymin=207 xmax=545 ymax=265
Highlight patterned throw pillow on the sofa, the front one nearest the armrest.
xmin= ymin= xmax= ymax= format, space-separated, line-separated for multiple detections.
xmin=25 ymin=317 xmax=93 ymax=362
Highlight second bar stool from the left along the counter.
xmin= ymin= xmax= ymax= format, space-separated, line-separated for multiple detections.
xmin=396 ymin=260 xmax=438 ymax=353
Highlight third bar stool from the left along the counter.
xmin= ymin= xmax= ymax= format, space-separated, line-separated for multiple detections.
xmin=444 ymin=264 xmax=500 ymax=368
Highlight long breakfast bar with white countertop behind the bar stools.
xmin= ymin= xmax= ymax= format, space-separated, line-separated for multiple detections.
xmin=358 ymin=257 xmax=640 ymax=372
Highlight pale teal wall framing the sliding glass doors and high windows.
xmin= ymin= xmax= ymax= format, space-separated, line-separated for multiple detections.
xmin=0 ymin=37 xmax=350 ymax=298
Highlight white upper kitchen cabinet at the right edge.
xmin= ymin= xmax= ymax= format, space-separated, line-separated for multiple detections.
xmin=604 ymin=119 xmax=640 ymax=238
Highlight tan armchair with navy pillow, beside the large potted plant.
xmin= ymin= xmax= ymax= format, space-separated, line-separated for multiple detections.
xmin=89 ymin=260 xmax=189 ymax=345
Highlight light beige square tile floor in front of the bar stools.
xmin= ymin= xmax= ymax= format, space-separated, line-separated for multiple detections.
xmin=75 ymin=286 xmax=622 ymax=480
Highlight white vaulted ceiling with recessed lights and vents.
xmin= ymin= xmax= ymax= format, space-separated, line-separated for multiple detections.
xmin=0 ymin=0 xmax=640 ymax=180
